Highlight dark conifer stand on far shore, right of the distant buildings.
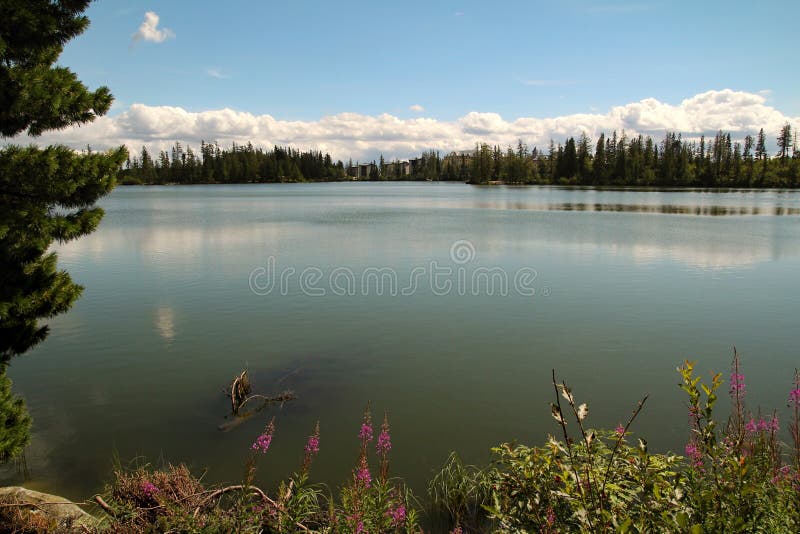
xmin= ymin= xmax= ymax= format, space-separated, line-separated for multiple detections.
xmin=456 ymin=124 xmax=800 ymax=187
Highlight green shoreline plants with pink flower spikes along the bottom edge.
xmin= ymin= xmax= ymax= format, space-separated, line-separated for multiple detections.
xmin=0 ymin=355 xmax=800 ymax=533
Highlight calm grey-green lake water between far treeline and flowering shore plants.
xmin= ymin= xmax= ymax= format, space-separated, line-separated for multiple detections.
xmin=2 ymin=183 xmax=800 ymax=499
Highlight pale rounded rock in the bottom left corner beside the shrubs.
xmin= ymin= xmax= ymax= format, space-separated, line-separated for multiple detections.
xmin=0 ymin=486 xmax=101 ymax=532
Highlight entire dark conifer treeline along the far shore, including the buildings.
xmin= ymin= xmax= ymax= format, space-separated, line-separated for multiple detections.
xmin=122 ymin=124 xmax=800 ymax=187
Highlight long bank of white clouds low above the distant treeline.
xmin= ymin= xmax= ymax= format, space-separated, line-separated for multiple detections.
xmin=14 ymin=89 xmax=800 ymax=160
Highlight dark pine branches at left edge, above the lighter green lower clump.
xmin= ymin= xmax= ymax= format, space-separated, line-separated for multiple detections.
xmin=0 ymin=0 xmax=127 ymax=363
